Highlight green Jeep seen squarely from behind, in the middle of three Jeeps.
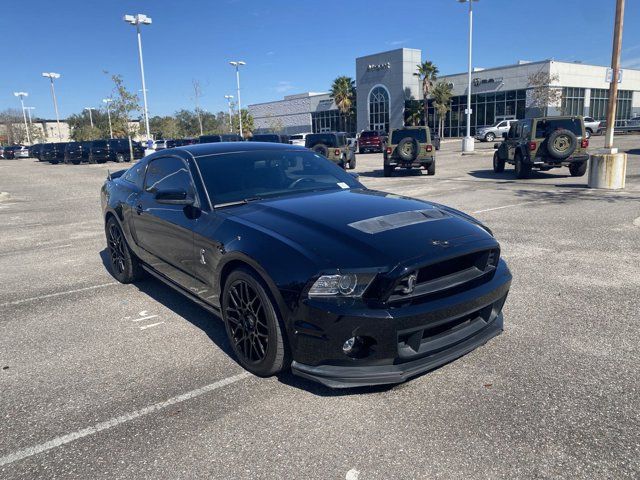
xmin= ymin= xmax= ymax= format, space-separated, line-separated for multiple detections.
xmin=384 ymin=127 xmax=436 ymax=177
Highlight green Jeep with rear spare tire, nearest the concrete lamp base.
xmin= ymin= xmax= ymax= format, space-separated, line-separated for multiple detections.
xmin=493 ymin=116 xmax=589 ymax=178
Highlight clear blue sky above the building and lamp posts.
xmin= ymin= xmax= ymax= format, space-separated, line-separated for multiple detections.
xmin=0 ymin=0 xmax=640 ymax=118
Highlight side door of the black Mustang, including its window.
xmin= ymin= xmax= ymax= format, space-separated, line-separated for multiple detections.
xmin=132 ymin=156 xmax=198 ymax=289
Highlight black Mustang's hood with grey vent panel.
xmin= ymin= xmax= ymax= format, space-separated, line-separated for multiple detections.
xmin=227 ymin=189 xmax=498 ymax=270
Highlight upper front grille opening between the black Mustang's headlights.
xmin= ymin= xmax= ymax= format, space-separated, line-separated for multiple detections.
xmin=387 ymin=248 xmax=500 ymax=303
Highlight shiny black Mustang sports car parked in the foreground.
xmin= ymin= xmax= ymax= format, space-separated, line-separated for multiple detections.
xmin=101 ymin=142 xmax=511 ymax=387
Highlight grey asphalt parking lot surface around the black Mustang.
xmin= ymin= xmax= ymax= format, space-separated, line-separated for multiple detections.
xmin=0 ymin=136 xmax=640 ymax=480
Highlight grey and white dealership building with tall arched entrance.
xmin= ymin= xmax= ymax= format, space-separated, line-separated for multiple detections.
xmin=249 ymin=48 xmax=640 ymax=137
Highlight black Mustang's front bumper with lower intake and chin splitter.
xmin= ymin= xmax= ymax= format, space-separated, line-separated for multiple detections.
xmin=291 ymin=261 xmax=511 ymax=388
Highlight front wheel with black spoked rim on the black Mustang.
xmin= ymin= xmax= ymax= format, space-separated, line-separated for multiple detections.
xmin=222 ymin=268 xmax=289 ymax=377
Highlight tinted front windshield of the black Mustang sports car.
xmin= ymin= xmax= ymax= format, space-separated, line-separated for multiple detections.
xmin=196 ymin=150 xmax=361 ymax=206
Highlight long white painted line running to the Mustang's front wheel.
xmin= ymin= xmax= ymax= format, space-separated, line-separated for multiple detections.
xmin=0 ymin=372 xmax=251 ymax=467
